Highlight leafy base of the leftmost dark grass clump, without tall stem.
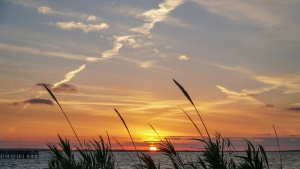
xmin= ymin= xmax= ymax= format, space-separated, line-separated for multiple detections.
xmin=47 ymin=136 xmax=115 ymax=169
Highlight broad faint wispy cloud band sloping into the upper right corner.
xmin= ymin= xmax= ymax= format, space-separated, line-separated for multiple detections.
xmin=192 ymin=0 xmax=300 ymax=40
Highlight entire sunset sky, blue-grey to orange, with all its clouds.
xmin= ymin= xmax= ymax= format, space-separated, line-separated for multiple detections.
xmin=0 ymin=0 xmax=300 ymax=150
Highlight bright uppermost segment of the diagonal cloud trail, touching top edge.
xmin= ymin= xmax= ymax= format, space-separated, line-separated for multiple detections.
xmin=131 ymin=0 xmax=183 ymax=34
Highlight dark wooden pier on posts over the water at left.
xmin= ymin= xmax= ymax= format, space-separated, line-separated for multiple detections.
xmin=0 ymin=150 xmax=39 ymax=159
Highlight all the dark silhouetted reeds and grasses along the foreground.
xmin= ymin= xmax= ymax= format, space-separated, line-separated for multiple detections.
xmin=44 ymin=80 xmax=282 ymax=169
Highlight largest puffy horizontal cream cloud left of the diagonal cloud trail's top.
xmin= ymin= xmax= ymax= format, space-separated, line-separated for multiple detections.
xmin=48 ymin=21 xmax=109 ymax=33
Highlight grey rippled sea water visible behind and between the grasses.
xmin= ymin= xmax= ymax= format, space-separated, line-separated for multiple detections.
xmin=0 ymin=151 xmax=300 ymax=169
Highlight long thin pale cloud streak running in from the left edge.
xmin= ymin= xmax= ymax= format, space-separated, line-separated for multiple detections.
xmin=0 ymin=43 xmax=91 ymax=60
